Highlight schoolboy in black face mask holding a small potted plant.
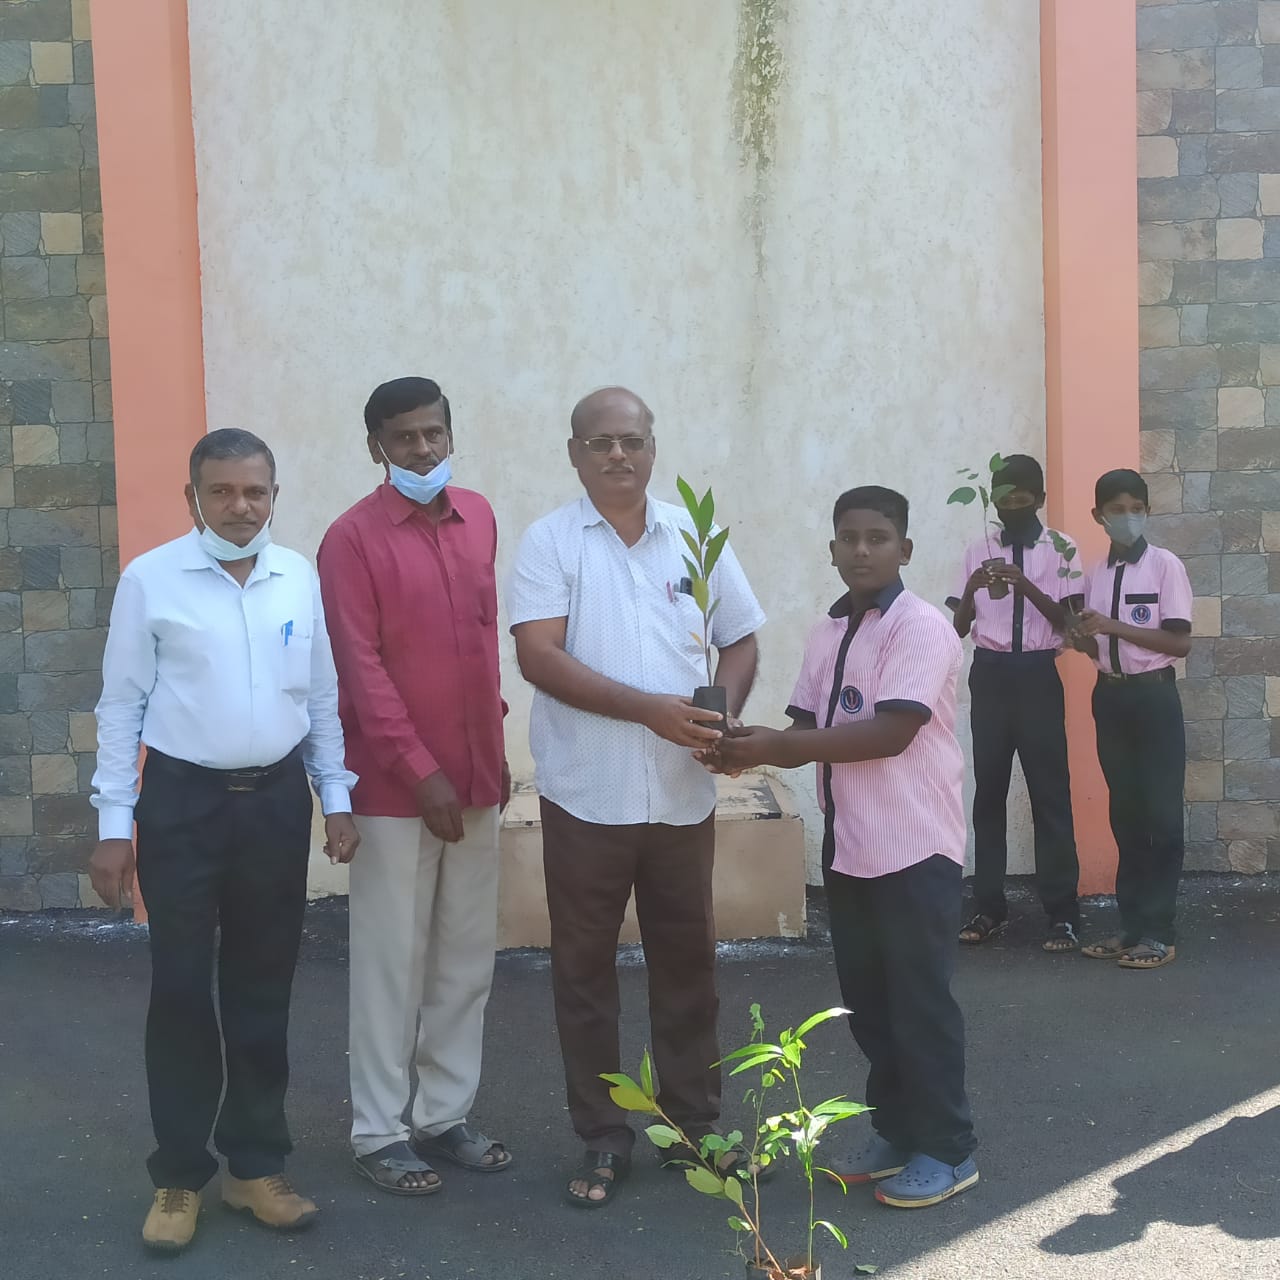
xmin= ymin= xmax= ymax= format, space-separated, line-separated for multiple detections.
xmin=948 ymin=453 xmax=1080 ymax=951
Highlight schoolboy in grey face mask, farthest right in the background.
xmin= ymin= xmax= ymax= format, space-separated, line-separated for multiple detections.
xmin=1071 ymin=470 xmax=1192 ymax=969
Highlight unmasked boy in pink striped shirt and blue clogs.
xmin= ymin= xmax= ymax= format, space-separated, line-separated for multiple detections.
xmin=718 ymin=485 xmax=978 ymax=1208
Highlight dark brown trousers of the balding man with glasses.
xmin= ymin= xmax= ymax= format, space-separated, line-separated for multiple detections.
xmin=541 ymin=799 xmax=721 ymax=1156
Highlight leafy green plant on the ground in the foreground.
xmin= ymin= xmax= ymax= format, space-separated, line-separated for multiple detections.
xmin=602 ymin=1005 xmax=876 ymax=1280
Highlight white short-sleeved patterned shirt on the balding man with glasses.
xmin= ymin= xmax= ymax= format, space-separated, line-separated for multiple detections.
xmin=507 ymin=498 xmax=764 ymax=827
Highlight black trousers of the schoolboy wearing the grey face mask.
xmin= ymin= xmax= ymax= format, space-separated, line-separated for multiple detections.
xmin=1093 ymin=680 xmax=1187 ymax=943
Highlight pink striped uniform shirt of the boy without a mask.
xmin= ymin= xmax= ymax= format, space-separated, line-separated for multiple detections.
xmin=787 ymin=582 xmax=966 ymax=878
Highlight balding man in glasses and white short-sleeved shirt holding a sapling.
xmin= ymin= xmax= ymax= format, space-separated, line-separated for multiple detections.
xmin=507 ymin=387 xmax=764 ymax=1208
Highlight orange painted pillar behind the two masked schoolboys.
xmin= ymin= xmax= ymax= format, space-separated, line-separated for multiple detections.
xmin=1041 ymin=0 xmax=1138 ymax=893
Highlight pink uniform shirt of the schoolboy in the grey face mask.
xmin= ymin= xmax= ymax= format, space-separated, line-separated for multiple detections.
xmin=1084 ymin=538 xmax=1192 ymax=676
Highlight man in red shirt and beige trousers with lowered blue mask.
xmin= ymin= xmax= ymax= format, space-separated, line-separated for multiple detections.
xmin=319 ymin=378 xmax=511 ymax=1196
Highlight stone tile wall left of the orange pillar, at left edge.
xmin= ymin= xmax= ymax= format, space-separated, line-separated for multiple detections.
xmin=0 ymin=0 xmax=111 ymax=910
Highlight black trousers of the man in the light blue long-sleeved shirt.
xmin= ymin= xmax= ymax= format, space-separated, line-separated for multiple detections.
xmin=136 ymin=753 xmax=311 ymax=1190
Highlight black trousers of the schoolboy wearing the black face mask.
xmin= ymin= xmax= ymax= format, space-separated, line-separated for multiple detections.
xmin=969 ymin=649 xmax=1080 ymax=925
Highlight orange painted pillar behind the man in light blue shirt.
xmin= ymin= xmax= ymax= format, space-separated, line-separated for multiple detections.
xmin=90 ymin=0 xmax=205 ymax=919
